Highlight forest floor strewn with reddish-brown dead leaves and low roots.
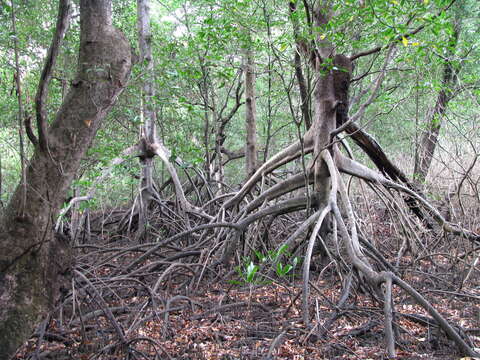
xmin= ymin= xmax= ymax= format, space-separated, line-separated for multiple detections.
xmin=11 ymin=210 xmax=480 ymax=360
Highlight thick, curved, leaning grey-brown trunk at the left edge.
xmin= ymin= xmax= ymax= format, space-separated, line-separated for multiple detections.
xmin=0 ymin=0 xmax=131 ymax=360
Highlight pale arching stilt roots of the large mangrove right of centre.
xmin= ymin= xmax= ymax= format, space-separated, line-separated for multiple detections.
xmin=218 ymin=149 xmax=477 ymax=357
